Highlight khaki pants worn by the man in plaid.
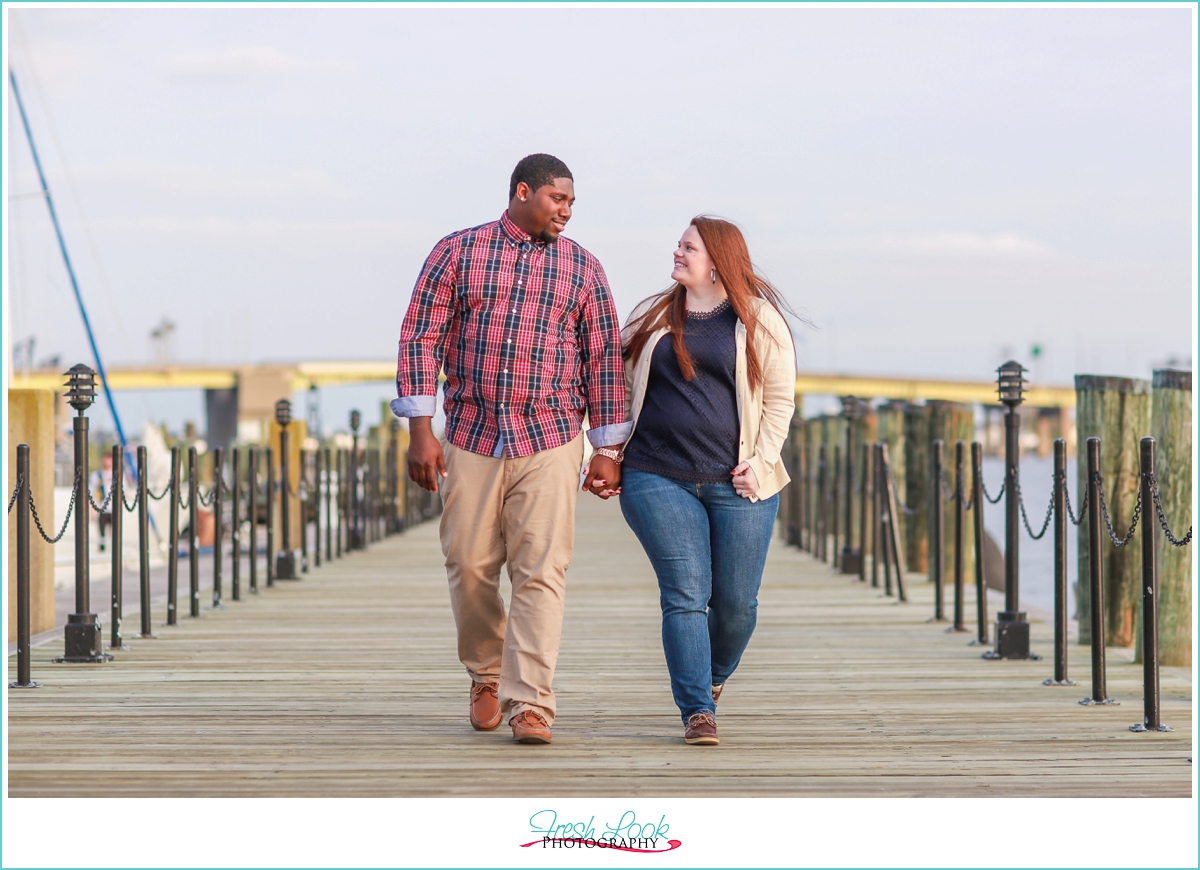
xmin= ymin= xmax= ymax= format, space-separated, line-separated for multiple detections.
xmin=440 ymin=434 xmax=583 ymax=724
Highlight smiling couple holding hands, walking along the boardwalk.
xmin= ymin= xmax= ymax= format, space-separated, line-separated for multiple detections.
xmin=391 ymin=154 xmax=796 ymax=745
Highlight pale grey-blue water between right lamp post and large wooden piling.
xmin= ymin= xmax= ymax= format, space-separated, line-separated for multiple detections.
xmin=983 ymin=455 xmax=1082 ymax=619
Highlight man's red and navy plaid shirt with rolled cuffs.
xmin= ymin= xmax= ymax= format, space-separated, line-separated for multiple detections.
xmin=391 ymin=211 xmax=631 ymax=457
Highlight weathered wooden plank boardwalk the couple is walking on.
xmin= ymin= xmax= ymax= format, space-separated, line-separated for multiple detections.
xmin=8 ymin=497 xmax=1193 ymax=798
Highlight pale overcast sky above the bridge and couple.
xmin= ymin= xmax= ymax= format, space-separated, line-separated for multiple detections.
xmin=5 ymin=6 xmax=1194 ymax=432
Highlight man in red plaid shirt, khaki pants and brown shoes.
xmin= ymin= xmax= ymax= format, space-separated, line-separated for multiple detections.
xmin=391 ymin=154 xmax=632 ymax=743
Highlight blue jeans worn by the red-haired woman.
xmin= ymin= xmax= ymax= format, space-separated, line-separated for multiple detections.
xmin=620 ymin=468 xmax=779 ymax=722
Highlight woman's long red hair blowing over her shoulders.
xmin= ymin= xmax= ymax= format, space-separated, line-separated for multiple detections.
xmin=623 ymin=215 xmax=787 ymax=390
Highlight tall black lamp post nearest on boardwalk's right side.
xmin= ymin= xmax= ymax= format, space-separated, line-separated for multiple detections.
xmin=983 ymin=360 xmax=1042 ymax=659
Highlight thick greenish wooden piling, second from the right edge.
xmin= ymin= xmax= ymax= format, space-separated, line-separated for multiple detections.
xmin=1080 ymin=374 xmax=1152 ymax=643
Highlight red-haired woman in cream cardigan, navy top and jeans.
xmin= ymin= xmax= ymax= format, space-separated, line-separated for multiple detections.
xmin=592 ymin=217 xmax=796 ymax=745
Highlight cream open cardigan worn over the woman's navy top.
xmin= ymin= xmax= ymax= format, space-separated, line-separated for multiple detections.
xmin=622 ymin=298 xmax=796 ymax=502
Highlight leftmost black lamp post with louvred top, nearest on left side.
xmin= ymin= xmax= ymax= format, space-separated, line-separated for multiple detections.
xmin=55 ymin=362 xmax=112 ymax=662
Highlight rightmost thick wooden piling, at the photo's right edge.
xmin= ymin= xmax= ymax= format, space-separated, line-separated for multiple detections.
xmin=1138 ymin=368 xmax=1195 ymax=666
